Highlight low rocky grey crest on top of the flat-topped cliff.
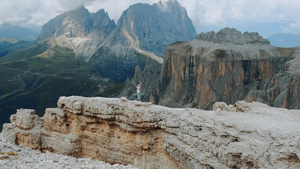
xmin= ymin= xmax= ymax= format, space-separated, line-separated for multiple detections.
xmin=196 ymin=27 xmax=270 ymax=45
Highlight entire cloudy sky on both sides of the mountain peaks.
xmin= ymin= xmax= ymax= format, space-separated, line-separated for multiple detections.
xmin=0 ymin=0 xmax=300 ymax=37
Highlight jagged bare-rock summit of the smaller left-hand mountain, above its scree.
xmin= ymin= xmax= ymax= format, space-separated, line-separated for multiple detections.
xmin=38 ymin=6 xmax=116 ymax=41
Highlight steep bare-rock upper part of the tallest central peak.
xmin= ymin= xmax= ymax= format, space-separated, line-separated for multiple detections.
xmin=112 ymin=0 xmax=196 ymax=57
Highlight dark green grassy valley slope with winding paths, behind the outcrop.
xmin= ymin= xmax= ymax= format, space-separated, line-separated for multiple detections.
xmin=0 ymin=43 xmax=122 ymax=129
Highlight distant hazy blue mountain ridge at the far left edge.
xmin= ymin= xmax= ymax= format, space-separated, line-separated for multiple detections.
xmin=0 ymin=23 xmax=39 ymax=41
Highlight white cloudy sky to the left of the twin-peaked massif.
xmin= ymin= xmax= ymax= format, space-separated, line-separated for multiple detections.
xmin=0 ymin=0 xmax=100 ymax=25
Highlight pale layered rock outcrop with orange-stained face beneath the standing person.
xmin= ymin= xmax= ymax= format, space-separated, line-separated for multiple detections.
xmin=2 ymin=96 xmax=300 ymax=169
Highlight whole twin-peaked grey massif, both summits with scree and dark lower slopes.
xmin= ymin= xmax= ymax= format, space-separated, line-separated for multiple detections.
xmin=38 ymin=0 xmax=196 ymax=82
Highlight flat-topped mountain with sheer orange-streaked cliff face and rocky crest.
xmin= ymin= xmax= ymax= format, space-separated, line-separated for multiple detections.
xmin=158 ymin=28 xmax=300 ymax=109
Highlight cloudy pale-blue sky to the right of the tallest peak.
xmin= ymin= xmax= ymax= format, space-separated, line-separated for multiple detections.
xmin=179 ymin=0 xmax=300 ymax=36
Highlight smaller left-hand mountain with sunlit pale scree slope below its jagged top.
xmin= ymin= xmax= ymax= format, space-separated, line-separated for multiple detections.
xmin=37 ymin=6 xmax=116 ymax=60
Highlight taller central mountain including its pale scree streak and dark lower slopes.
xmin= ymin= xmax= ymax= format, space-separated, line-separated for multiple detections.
xmin=91 ymin=1 xmax=196 ymax=81
